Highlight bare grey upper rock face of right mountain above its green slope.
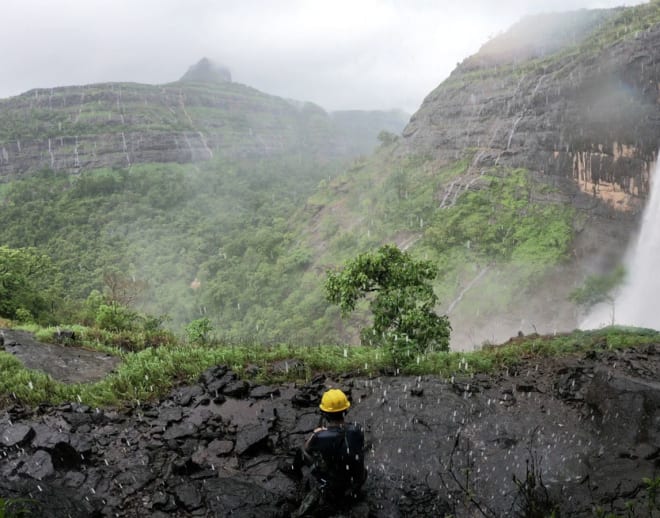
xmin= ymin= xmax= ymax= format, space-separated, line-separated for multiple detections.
xmin=404 ymin=6 xmax=660 ymax=211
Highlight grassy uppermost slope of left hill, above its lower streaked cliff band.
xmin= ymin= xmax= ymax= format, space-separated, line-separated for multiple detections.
xmin=0 ymin=83 xmax=312 ymax=141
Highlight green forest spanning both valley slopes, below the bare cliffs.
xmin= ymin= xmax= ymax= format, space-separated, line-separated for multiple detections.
xmin=0 ymin=141 xmax=572 ymax=350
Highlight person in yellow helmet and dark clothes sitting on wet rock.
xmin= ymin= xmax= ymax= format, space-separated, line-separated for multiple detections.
xmin=294 ymin=389 xmax=367 ymax=517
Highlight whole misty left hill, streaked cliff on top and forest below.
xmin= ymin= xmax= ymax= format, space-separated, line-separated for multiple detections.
xmin=0 ymin=76 xmax=407 ymax=342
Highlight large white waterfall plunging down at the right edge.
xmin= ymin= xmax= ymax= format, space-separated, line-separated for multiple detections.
xmin=580 ymin=160 xmax=660 ymax=329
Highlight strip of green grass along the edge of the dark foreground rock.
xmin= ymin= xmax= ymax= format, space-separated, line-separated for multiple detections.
xmin=0 ymin=327 xmax=660 ymax=407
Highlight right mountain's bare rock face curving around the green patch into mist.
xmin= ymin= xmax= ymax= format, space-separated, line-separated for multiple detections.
xmin=390 ymin=2 xmax=660 ymax=350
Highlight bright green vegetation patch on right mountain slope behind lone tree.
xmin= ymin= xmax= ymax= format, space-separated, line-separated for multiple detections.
xmin=308 ymin=147 xmax=575 ymax=342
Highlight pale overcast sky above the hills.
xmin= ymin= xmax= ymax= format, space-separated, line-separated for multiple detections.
xmin=0 ymin=0 xmax=646 ymax=115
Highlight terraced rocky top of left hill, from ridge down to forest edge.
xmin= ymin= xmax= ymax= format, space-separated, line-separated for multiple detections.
xmin=0 ymin=77 xmax=405 ymax=179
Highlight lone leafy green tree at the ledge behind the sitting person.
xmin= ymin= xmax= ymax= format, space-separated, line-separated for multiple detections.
xmin=325 ymin=245 xmax=451 ymax=363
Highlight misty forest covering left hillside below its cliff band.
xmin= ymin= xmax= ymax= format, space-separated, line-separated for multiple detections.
xmin=0 ymin=157 xmax=346 ymax=340
